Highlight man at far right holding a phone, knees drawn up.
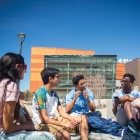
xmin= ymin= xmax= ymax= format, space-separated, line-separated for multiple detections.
xmin=112 ymin=73 xmax=140 ymax=133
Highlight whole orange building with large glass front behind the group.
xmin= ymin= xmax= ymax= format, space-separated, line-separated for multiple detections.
xmin=30 ymin=47 xmax=124 ymax=98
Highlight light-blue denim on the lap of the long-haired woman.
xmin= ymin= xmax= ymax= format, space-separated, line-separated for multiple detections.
xmin=0 ymin=131 xmax=56 ymax=140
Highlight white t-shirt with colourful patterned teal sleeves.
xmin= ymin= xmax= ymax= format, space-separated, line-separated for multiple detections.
xmin=32 ymin=86 xmax=60 ymax=126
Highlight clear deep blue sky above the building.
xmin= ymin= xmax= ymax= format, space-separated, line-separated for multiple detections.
xmin=0 ymin=0 xmax=140 ymax=91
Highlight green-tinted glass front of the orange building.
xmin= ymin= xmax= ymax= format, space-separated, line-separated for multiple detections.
xmin=44 ymin=55 xmax=117 ymax=98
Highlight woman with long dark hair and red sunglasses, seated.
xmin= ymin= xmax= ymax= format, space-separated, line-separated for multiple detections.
xmin=0 ymin=53 xmax=55 ymax=140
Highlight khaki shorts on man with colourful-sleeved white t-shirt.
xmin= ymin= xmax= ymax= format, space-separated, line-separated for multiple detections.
xmin=35 ymin=117 xmax=77 ymax=137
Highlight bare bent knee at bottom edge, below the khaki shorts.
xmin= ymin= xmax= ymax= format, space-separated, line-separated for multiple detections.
xmin=56 ymin=129 xmax=71 ymax=140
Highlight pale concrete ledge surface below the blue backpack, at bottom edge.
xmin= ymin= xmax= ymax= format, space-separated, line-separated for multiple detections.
xmin=70 ymin=132 xmax=121 ymax=140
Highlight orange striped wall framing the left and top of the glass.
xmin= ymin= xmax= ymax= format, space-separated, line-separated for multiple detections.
xmin=30 ymin=47 xmax=95 ymax=92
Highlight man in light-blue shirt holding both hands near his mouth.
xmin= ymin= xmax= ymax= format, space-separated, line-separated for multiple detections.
xmin=66 ymin=75 xmax=96 ymax=115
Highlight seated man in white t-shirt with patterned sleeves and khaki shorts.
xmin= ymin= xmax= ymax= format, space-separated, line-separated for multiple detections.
xmin=32 ymin=68 xmax=88 ymax=140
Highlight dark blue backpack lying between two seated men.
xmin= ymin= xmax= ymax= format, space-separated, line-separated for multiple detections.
xmin=88 ymin=116 xmax=123 ymax=134
